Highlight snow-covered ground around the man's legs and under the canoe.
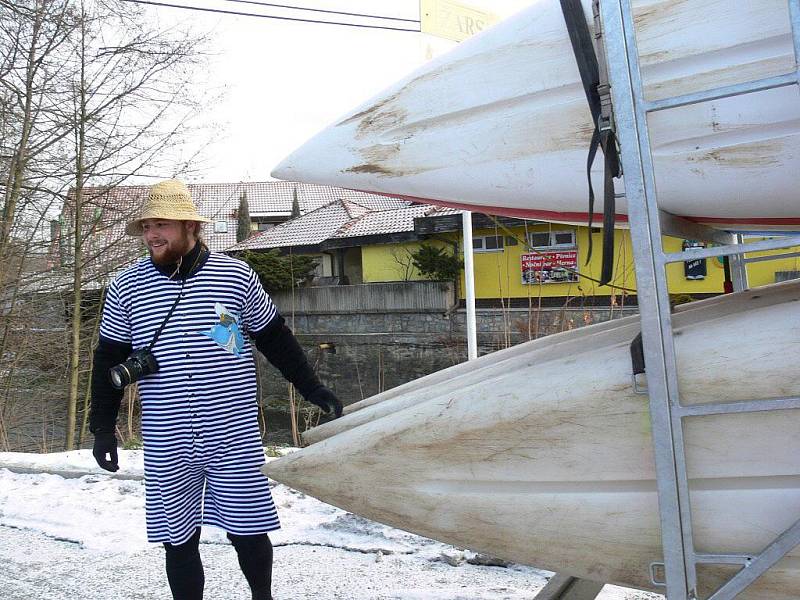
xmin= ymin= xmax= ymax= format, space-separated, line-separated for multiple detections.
xmin=0 ymin=450 xmax=661 ymax=600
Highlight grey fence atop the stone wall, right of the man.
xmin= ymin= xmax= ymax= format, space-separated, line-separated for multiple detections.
xmin=271 ymin=281 xmax=455 ymax=315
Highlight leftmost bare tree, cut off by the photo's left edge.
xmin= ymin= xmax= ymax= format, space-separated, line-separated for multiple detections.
xmin=0 ymin=0 xmax=74 ymax=448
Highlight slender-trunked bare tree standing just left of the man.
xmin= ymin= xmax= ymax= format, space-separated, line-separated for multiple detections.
xmin=59 ymin=0 xmax=211 ymax=449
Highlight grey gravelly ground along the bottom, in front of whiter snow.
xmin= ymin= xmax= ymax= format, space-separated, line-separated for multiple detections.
xmin=0 ymin=526 xmax=556 ymax=600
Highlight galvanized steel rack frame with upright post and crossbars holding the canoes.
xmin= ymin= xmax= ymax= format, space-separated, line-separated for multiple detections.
xmin=599 ymin=0 xmax=800 ymax=600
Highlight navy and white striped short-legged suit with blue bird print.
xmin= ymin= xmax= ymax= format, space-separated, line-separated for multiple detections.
xmin=100 ymin=253 xmax=280 ymax=544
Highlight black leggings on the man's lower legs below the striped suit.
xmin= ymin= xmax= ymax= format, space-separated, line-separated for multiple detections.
xmin=164 ymin=527 xmax=272 ymax=600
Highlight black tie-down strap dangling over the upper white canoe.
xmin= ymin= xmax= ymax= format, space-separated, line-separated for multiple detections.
xmin=561 ymin=0 xmax=622 ymax=285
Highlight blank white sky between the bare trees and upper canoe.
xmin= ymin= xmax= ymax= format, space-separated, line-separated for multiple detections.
xmin=148 ymin=0 xmax=535 ymax=183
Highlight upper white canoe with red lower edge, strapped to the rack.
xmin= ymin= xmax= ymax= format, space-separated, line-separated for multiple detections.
xmin=272 ymin=0 xmax=800 ymax=231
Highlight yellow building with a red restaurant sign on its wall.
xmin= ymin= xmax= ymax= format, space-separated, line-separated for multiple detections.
xmin=361 ymin=215 xmax=800 ymax=303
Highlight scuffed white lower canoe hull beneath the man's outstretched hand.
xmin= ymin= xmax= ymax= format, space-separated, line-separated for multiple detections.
xmin=265 ymin=281 xmax=800 ymax=600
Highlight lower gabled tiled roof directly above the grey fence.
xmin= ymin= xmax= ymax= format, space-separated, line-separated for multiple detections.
xmin=229 ymin=200 xmax=461 ymax=250
